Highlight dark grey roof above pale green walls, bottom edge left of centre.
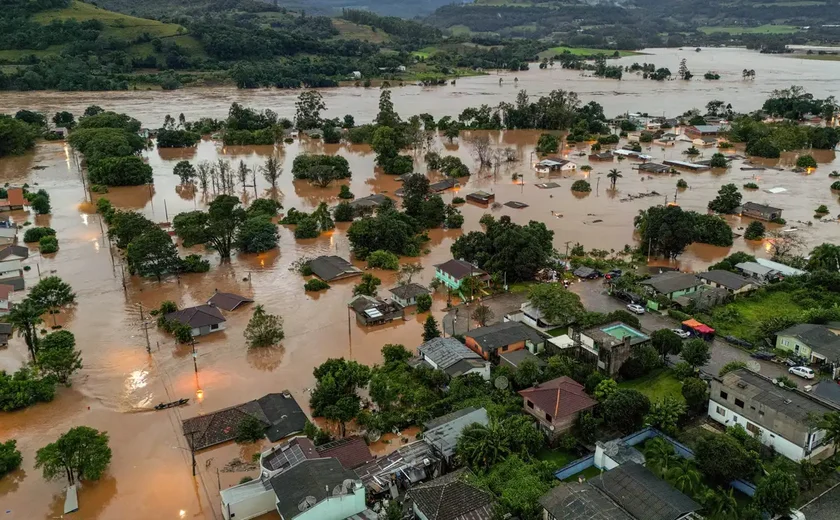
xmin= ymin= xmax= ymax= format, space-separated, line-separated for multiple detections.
xmin=271 ymin=458 xmax=358 ymax=520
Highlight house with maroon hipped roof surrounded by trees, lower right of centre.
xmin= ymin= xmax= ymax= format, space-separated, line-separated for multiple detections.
xmin=519 ymin=376 xmax=598 ymax=435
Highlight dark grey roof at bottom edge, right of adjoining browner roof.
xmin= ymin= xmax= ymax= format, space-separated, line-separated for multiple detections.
xmin=589 ymin=462 xmax=700 ymax=520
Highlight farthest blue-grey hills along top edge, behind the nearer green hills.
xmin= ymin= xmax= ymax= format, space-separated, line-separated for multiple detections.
xmin=97 ymin=0 xmax=452 ymax=18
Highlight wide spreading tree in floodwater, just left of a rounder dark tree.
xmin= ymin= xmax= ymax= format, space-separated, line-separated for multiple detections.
xmin=172 ymin=195 xmax=246 ymax=260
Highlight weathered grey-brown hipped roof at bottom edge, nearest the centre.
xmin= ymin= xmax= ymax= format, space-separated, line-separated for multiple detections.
xmin=408 ymin=468 xmax=494 ymax=520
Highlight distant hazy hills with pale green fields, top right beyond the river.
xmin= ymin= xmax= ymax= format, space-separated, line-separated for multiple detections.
xmin=426 ymin=0 xmax=840 ymax=49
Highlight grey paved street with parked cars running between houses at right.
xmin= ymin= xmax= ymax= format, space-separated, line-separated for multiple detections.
xmin=570 ymin=280 xmax=792 ymax=381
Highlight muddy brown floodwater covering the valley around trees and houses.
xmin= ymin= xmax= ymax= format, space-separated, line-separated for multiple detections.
xmin=0 ymin=50 xmax=840 ymax=520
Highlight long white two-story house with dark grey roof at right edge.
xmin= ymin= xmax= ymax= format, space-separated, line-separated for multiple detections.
xmin=709 ymin=368 xmax=838 ymax=462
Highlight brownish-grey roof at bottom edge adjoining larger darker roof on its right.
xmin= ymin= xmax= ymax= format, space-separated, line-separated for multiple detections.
xmin=540 ymin=482 xmax=634 ymax=520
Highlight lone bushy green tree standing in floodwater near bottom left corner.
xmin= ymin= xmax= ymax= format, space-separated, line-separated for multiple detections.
xmin=35 ymin=426 xmax=111 ymax=485
